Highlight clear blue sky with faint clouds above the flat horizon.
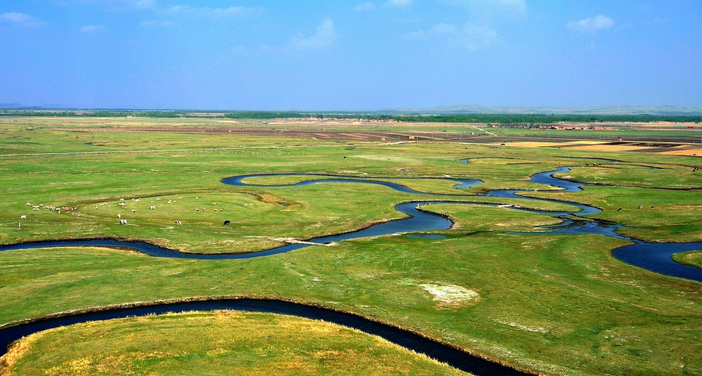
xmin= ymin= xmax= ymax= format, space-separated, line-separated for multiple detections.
xmin=0 ymin=0 xmax=702 ymax=110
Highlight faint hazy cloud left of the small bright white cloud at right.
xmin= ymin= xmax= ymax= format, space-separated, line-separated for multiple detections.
xmin=407 ymin=23 xmax=497 ymax=51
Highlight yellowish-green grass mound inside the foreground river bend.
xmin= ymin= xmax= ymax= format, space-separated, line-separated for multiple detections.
xmin=5 ymin=311 xmax=462 ymax=376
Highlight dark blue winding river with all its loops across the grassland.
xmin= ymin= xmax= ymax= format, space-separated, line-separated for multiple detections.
xmin=0 ymin=160 xmax=702 ymax=375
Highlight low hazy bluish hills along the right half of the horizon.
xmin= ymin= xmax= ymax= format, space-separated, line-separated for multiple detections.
xmin=388 ymin=105 xmax=702 ymax=115
